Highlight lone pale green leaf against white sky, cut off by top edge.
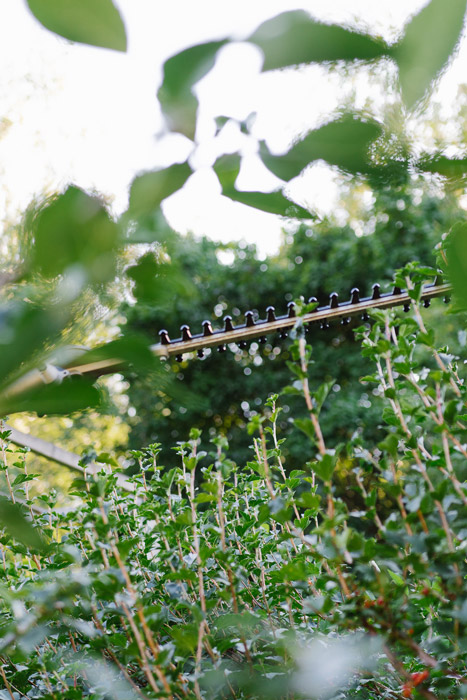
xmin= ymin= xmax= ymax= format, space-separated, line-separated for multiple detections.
xmin=27 ymin=0 xmax=127 ymax=51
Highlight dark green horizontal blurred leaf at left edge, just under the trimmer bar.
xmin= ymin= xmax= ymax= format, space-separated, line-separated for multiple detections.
xmin=0 ymin=377 xmax=100 ymax=415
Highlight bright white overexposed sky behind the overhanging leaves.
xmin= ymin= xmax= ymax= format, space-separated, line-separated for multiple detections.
xmin=0 ymin=0 xmax=467 ymax=254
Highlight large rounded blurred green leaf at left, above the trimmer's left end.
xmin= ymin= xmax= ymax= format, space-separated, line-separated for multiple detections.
xmin=32 ymin=186 xmax=119 ymax=284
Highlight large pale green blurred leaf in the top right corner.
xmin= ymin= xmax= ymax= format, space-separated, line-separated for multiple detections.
xmin=391 ymin=0 xmax=466 ymax=109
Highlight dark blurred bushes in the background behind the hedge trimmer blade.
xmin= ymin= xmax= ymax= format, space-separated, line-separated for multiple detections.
xmin=122 ymin=183 xmax=460 ymax=464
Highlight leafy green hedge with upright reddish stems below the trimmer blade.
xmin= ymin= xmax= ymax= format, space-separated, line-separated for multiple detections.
xmin=0 ymin=267 xmax=467 ymax=700
